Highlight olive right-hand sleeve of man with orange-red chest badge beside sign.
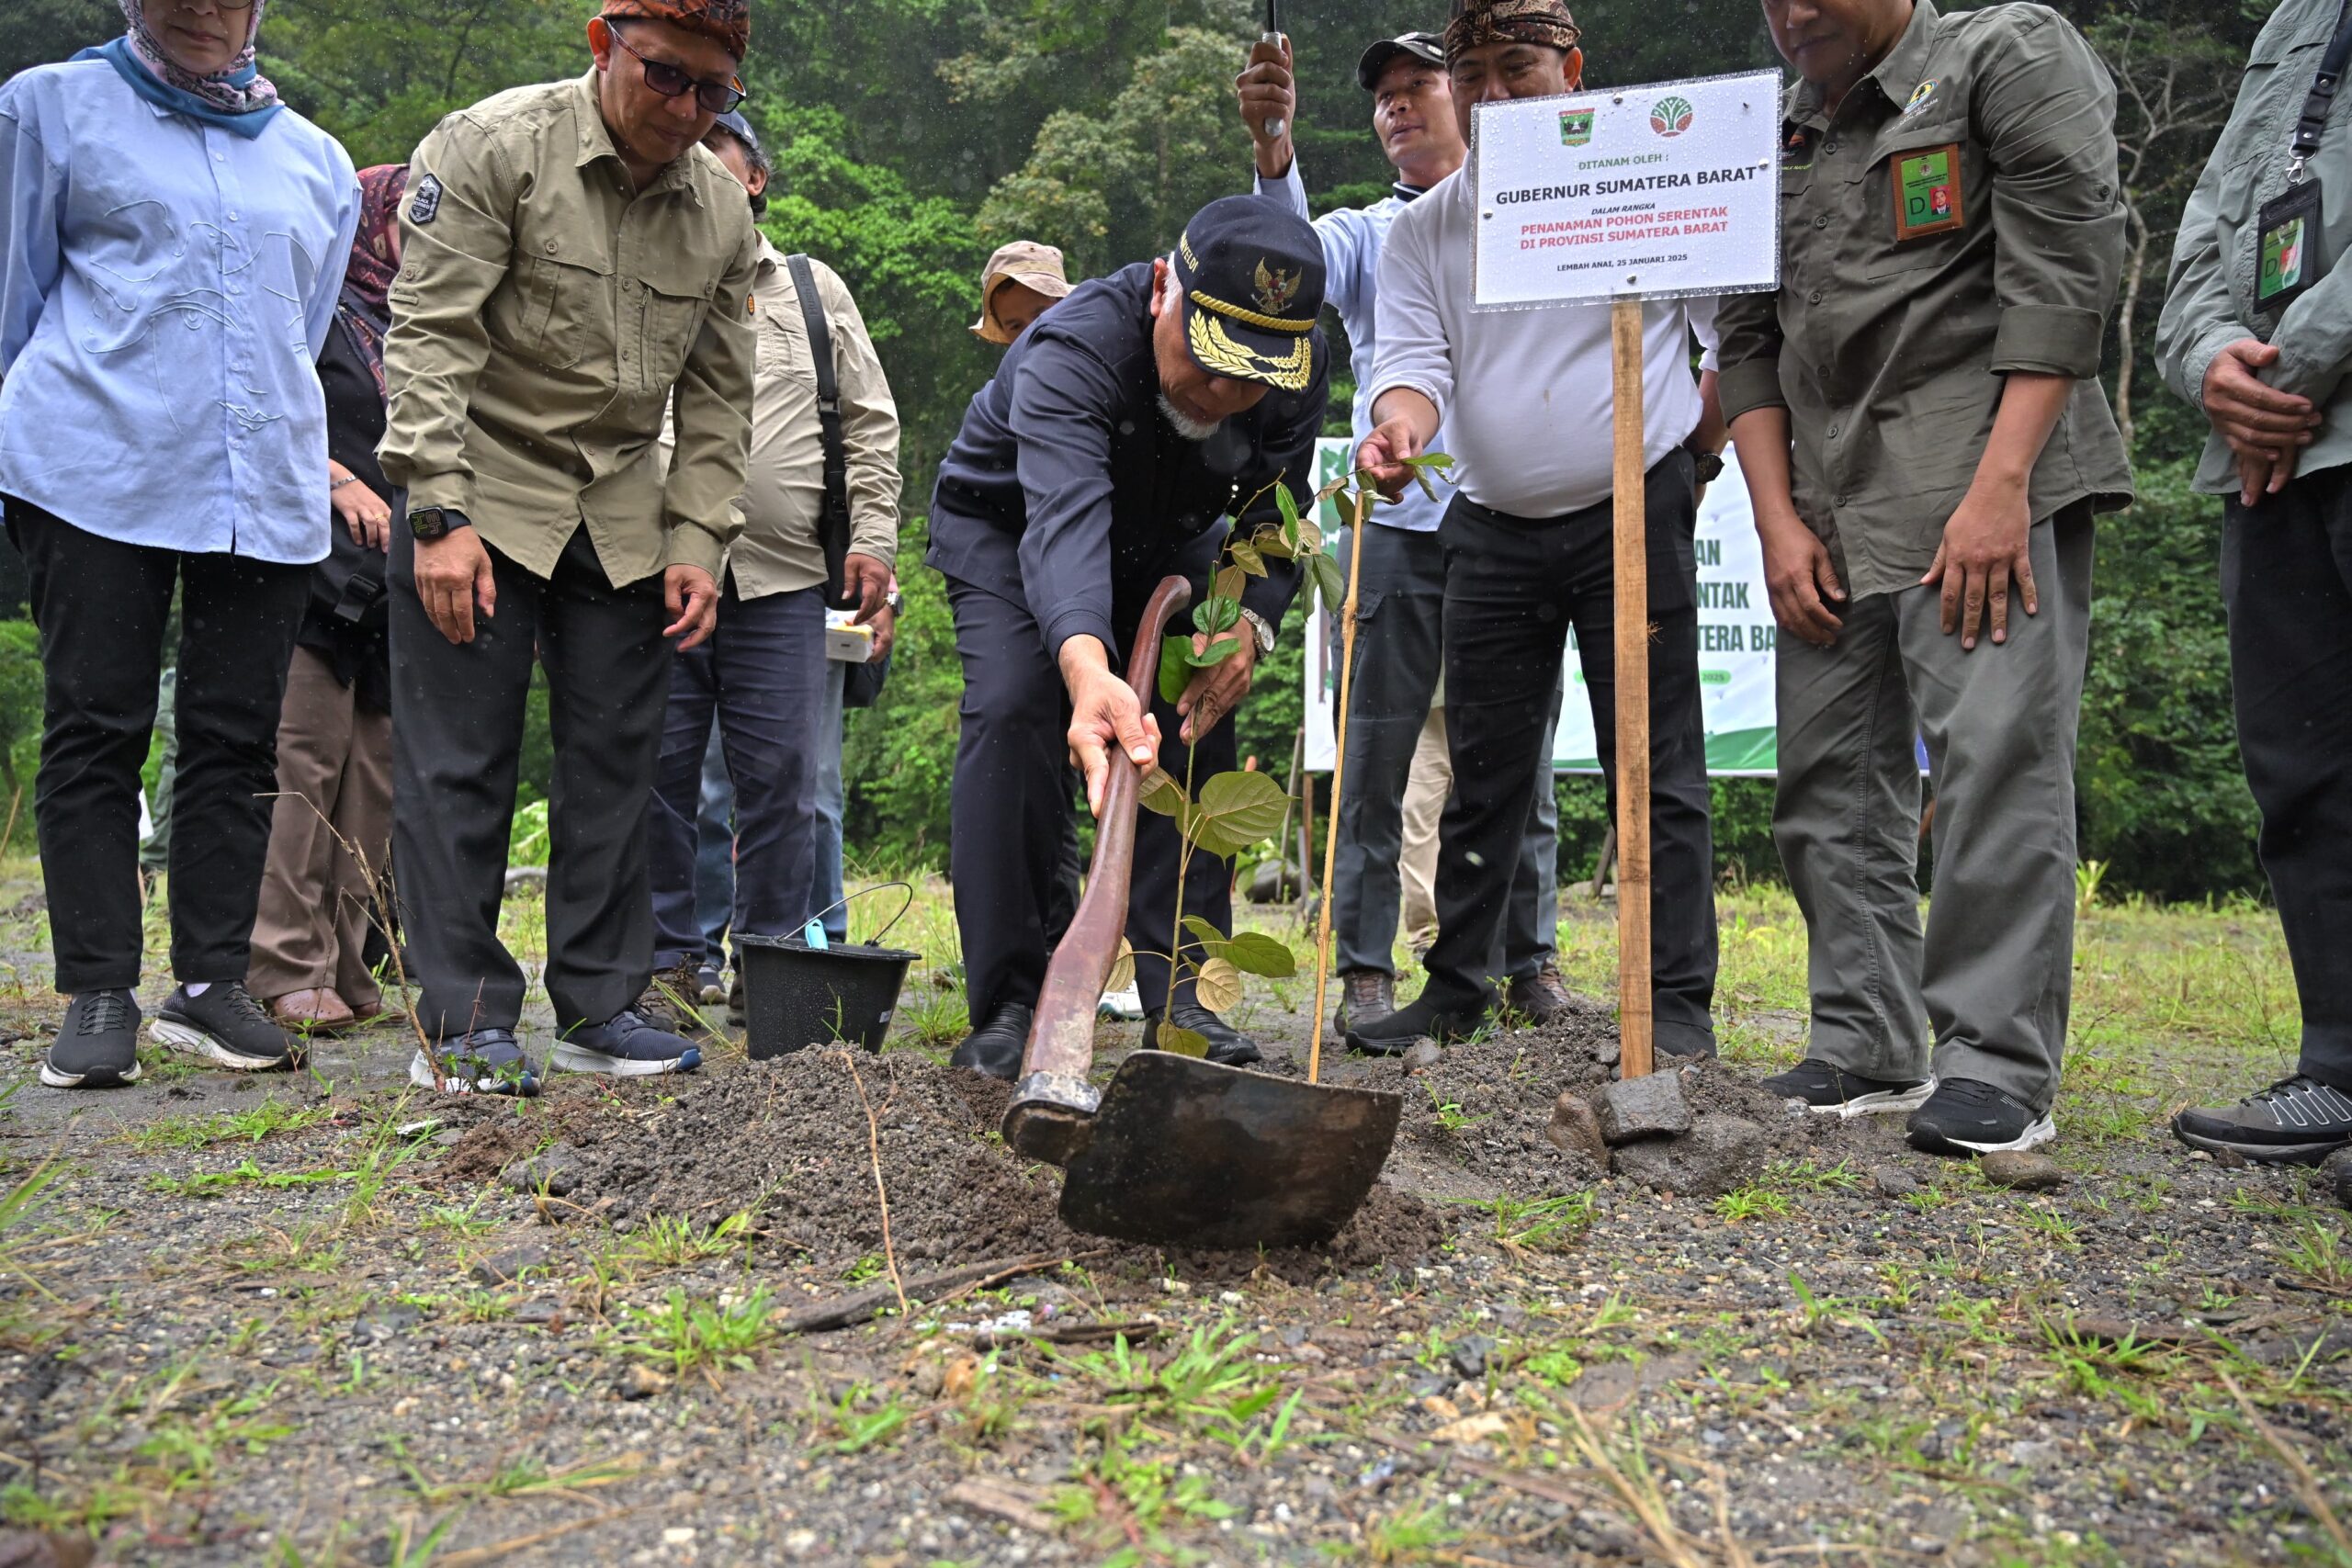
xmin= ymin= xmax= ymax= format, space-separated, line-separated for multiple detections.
xmin=1978 ymin=17 xmax=2124 ymax=381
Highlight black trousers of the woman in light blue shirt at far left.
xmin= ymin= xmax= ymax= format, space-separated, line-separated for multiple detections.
xmin=5 ymin=499 xmax=311 ymax=992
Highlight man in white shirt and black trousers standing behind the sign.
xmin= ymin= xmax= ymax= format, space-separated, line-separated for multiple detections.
xmin=1348 ymin=0 xmax=1722 ymax=1055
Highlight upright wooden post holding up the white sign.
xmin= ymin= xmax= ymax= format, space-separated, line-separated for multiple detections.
xmin=1618 ymin=299 xmax=1654 ymax=1079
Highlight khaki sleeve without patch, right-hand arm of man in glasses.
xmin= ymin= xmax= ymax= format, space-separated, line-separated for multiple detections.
xmin=661 ymin=232 xmax=760 ymax=576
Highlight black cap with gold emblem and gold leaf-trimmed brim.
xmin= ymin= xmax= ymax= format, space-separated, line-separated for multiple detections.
xmin=1176 ymin=195 xmax=1324 ymax=392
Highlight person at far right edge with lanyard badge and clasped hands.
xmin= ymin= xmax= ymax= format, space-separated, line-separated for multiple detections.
xmin=2157 ymin=0 xmax=2352 ymax=1164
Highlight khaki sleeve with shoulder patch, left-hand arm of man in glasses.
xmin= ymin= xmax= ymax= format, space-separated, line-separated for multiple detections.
xmin=377 ymin=115 xmax=517 ymax=513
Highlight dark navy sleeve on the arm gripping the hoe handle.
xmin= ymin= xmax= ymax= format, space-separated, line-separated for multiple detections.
xmin=1004 ymin=339 xmax=1120 ymax=663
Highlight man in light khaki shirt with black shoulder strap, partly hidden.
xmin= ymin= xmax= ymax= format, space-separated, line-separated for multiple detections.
xmin=644 ymin=115 xmax=899 ymax=1018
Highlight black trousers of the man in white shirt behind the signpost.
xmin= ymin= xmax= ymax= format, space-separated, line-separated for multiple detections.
xmin=1423 ymin=451 xmax=1714 ymax=1054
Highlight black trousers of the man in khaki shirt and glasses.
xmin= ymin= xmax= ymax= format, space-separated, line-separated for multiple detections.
xmin=390 ymin=520 xmax=673 ymax=1039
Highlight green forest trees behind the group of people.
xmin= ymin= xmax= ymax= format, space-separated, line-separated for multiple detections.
xmin=0 ymin=0 xmax=2277 ymax=898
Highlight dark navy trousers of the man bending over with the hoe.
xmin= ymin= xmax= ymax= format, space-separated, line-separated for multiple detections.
xmin=948 ymin=554 xmax=1235 ymax=1025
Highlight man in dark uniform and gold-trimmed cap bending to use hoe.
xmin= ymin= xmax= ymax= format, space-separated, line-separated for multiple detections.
xmin=929 ymin=195 xmax=1327 ymax=1079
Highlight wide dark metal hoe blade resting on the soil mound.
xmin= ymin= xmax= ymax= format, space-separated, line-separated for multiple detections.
xmin=1061 ymin=1051 xmax=1404 ymax=1248
